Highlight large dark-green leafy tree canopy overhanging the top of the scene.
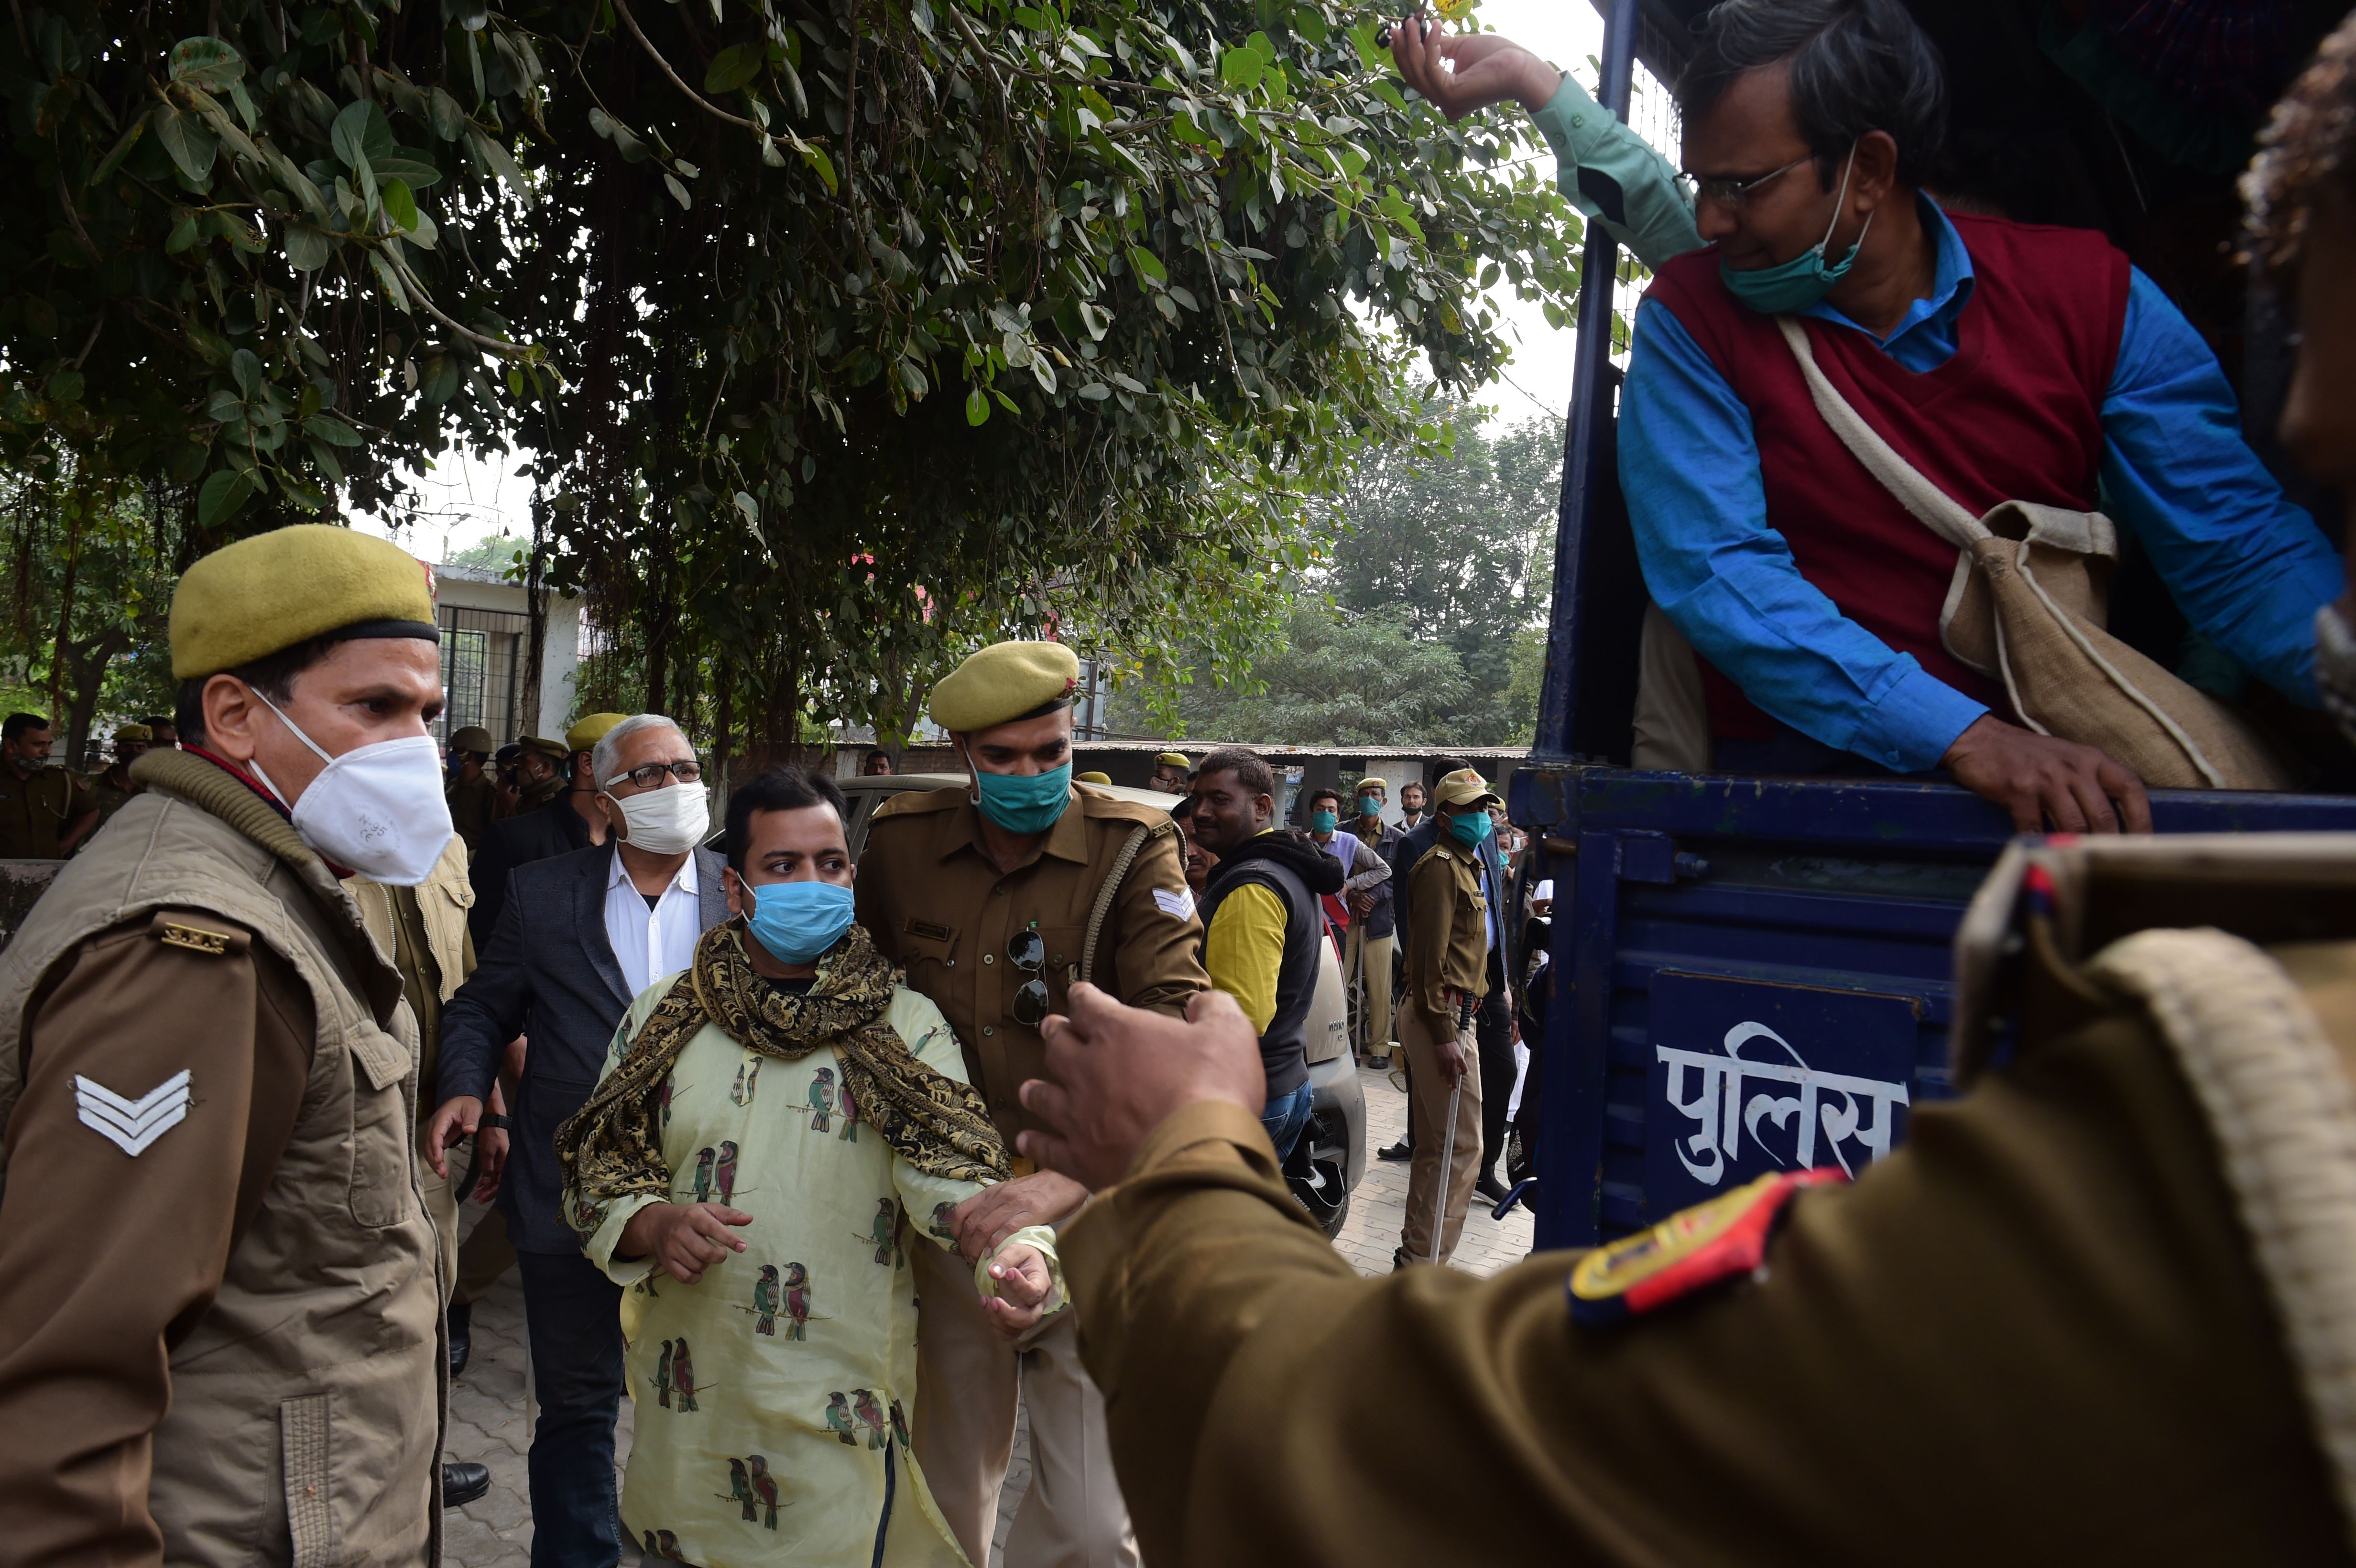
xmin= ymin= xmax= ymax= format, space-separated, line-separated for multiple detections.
xmin=0 ymin=0 xmax=1579 ymax=744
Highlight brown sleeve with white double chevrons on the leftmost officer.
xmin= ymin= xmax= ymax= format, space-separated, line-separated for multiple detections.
xmin=0 ymin=911 xmax=313 ymax=1563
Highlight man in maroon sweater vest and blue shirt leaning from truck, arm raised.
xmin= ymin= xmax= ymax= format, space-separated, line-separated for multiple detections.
xmin=1392 ymin=0 xmax=2340 ymax=831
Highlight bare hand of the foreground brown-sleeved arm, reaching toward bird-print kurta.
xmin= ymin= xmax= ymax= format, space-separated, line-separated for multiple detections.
xmin=1015 ymin=984 xmax=1267 ymax=1191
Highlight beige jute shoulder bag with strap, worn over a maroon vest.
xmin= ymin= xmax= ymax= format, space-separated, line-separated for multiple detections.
xmin=1777 ymin=316 xmax=2295 ymax=789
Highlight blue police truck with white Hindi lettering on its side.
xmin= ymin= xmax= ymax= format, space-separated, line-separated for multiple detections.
xmin=1510 ymin=0 xmax=2356 ymax=1248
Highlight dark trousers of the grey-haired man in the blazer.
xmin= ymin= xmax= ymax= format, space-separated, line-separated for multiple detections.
xmin=516 ymin=1252 xmax=622 ymax=1568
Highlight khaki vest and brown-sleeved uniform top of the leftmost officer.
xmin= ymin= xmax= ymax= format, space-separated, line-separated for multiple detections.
xmin=0 ymin=751 xmax=445 ymax=1568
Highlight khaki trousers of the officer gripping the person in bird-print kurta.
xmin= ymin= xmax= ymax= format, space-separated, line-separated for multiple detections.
xmin=909 ymin=1243 xmax=1138 ymax=1568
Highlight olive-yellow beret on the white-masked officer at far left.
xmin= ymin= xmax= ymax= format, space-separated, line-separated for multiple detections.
xmin=172 ymin=523 xmax=441 ymax=680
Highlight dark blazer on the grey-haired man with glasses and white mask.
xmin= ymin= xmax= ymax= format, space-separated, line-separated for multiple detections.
xmin=434 ymin=824 xmax=728 ymax=1252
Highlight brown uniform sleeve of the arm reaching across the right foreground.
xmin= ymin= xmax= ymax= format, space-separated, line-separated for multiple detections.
xmin=1050 ymin=989 xmax=2349 ymax=1568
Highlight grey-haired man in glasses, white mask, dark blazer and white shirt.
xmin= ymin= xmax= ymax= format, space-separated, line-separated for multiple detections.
xmin=426 ymin=713 xmax=728 ymax=1568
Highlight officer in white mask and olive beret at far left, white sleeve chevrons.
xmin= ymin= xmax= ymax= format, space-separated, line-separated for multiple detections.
xmin=0 ymin=525 xmax=450 ymax=1568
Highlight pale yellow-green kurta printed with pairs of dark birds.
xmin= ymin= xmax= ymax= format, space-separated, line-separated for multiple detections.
xmin=566 ymin=977 xmax=1063 ymax=1568
